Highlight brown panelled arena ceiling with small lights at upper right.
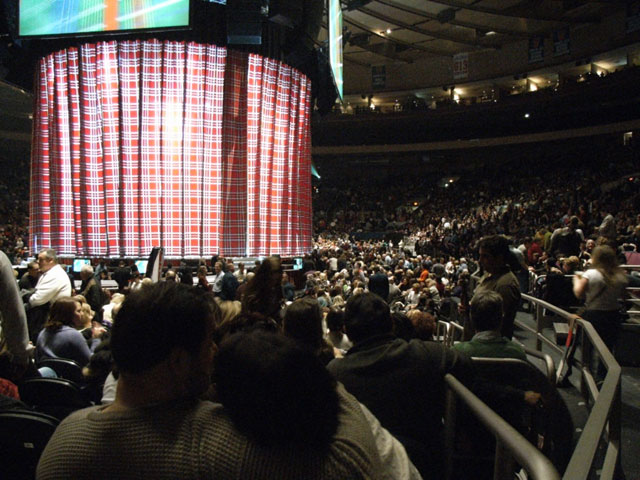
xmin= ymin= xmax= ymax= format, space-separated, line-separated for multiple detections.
xmin=320 ymin=0 xmax=640 ymax=111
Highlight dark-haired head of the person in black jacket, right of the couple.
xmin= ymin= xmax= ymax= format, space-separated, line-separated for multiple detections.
xmin=344 ymin=292 xmax=393 ymax=342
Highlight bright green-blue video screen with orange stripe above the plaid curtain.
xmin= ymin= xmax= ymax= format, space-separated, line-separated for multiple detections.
xmin=19 ymin=0 xmax=189 ymax=36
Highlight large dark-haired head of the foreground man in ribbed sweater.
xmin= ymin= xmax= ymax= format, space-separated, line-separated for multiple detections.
xmin=111 ymin=282 xmax=220 ymax=395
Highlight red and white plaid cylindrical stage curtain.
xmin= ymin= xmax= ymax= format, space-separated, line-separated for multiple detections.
xmin=30 ymin=40 xmax=311 ymax=258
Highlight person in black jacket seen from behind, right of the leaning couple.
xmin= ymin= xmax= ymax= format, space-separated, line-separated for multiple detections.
xmin=327 ymin=292 xmax=471 ymax=479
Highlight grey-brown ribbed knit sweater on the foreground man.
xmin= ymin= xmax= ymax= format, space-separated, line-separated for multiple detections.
xmin=36 ymin=388 xmax=380 ymax=480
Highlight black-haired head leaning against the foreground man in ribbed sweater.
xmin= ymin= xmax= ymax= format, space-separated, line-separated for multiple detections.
xmin=214 ymin=330 xmax=338 ymax=448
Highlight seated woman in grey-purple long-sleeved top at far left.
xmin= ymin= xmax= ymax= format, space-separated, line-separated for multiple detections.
xmin=36 ymin=297 xmax=99 ymax=366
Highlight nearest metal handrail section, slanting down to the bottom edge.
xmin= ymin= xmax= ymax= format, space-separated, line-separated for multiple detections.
xmin=445 ymin=374 xmax=560 ymax=480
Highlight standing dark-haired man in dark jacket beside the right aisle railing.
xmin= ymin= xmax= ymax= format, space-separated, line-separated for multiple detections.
xmin=471 ymin=235 xmax=520 ymax=339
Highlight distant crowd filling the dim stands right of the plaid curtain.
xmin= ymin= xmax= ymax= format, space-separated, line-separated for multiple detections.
xmin=314 ymin=144 xmax=640 ymax=257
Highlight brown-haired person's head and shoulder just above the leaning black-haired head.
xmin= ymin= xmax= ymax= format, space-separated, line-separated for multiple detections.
xmin=282 ymin=297 xmax=335 ymax=365
